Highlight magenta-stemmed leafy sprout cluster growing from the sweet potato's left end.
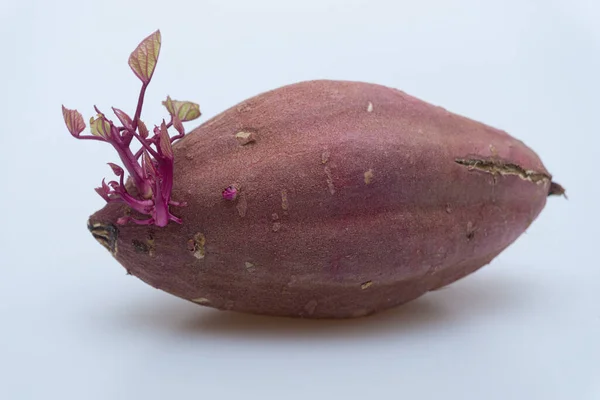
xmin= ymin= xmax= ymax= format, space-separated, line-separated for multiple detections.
xmin=62 ymin=30 xmax=201 ymax=227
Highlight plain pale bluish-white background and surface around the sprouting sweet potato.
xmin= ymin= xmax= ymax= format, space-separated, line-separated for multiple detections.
xmin=0 ymin=0 xmax=600 ymax=400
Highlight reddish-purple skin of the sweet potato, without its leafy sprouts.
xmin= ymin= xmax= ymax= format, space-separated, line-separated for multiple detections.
xmin=89 ymin=80 xmax=551 ymax=318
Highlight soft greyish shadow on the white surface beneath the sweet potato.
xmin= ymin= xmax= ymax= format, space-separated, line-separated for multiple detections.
xmin=108 ymin=273 xmax=528 ymax=340
